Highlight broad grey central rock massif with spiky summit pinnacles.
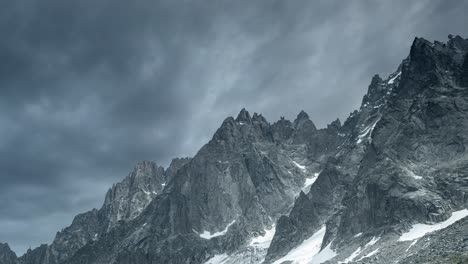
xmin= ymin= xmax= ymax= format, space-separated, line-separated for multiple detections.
xmin=64 ymin=109 xmax=338 ymax=263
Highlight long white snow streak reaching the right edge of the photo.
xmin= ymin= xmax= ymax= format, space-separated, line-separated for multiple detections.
xmin=398 ymin=209 xmax=468 ymax=241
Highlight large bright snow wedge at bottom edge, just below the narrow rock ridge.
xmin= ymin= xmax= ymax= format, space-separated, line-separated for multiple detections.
xmin=273 ymin=226 xmax=326 ymax=264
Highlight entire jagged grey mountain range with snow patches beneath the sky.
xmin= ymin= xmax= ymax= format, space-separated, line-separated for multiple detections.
xmin=0 ymin=35 xmax=468 ymax=264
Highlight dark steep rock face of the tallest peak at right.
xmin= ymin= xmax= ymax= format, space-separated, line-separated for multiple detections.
xmin=340 ymin=34 xmax=468 ymax=239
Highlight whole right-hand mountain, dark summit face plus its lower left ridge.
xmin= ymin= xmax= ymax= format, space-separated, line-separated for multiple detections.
xmin=267 ymin=36 xmax=468 ymax=263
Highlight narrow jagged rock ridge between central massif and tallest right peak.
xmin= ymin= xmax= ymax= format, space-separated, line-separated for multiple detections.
xmin=266 ymin=63 xmax=399 ymax=263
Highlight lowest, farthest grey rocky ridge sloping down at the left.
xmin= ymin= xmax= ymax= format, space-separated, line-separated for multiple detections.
xmin=0 ymin=158 xmax=190 ymax=264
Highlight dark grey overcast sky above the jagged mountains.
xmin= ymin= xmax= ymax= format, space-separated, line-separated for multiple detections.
xmin=0 ymin=0 xmax=468 ymax=254
